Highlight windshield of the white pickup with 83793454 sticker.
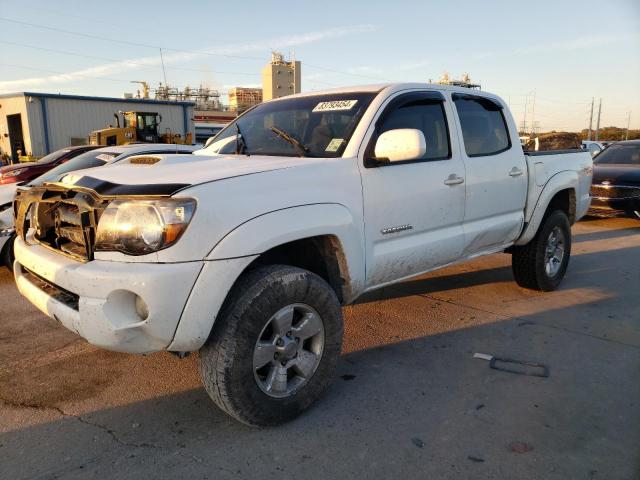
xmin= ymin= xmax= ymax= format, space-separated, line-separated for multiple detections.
xmin=212 ymin=92 xmax=376 ymax=158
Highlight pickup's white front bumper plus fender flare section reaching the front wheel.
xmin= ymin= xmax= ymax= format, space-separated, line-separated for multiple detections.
xmin=13 ymin=237 xmax=256 ymax=353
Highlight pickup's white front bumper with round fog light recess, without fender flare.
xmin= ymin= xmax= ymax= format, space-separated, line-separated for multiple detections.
xmin=14 ymin=237 xmax=202 ymax=353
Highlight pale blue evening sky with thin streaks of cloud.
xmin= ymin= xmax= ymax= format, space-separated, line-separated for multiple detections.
xmin=0 ymin=0 xmax=640 ymax=131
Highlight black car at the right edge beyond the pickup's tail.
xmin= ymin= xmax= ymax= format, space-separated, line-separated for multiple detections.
xmin=589 ymin=140 xmax=640 ymax=219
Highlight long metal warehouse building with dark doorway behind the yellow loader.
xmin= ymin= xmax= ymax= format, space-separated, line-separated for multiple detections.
xmin=0 ymin=92 xmax=195 ymax=161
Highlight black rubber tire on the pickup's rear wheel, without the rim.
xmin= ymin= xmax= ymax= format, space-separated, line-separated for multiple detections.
xmin=511 ymin=210 xmax=571 ymax=292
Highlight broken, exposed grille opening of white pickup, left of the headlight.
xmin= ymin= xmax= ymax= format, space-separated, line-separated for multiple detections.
xmin=14 ymin=185 xmax=106 ymax=262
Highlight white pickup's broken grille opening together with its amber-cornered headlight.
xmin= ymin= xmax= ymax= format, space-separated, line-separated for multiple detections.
xmin=14 ymin=177 xmax=196 ymax=262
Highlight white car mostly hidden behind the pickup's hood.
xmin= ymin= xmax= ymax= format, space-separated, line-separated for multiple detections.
xmin=0 ymin=143 xmax=197 ymax=268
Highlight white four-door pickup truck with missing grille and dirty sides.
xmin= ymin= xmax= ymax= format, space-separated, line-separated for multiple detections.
xmin=14 ymin=84 xmax=592 ymax=425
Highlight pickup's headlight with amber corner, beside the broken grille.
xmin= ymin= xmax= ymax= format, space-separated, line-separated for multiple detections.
xmin=96 ymin=198 xmax=196 ymax=255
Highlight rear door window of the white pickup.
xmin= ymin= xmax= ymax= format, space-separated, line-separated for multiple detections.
xmin=453 ymin=94 xmax=511 ymax=157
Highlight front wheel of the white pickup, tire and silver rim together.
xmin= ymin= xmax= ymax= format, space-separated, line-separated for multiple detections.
xmin=200 ymin=265 xmax=343 ymax=426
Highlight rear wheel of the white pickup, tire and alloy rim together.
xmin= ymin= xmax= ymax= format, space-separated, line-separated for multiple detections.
xmin=511 ymin=210 xmax=571 ymax=292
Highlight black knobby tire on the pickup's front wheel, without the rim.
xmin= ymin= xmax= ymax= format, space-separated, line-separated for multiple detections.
xmin=200 ymin=265 xmax=343 ymax=426
